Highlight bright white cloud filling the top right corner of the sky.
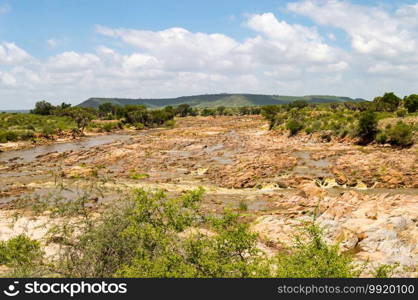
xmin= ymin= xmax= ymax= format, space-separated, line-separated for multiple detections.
xmin=288 ymin=0 xmax=418 ymax=60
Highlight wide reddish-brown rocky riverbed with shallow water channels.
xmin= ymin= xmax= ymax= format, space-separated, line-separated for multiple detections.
xmin=0 ymin=116 xmax=418 ymax=276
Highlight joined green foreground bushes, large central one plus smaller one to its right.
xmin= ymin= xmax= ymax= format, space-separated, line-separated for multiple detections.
xmin=22 ymin=190 xmax=357 ymax=278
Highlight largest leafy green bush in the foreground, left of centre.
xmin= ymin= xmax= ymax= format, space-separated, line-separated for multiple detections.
xmin=56 ymin=190 xmax=268 ymax=277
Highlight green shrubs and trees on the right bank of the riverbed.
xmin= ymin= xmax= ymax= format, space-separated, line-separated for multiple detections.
xmin=261 ymin=93 xmax=418 ymax=147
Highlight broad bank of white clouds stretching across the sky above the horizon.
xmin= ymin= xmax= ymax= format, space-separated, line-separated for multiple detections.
xmin=0 ymin=0 xmax=418 ymax=107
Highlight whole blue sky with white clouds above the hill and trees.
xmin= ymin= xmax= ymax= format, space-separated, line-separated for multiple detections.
xmin=0 ymin=0 xmax=418 ymax=109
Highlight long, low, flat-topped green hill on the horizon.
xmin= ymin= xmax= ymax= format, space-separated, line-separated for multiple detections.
xmin=78 ymin=94 xmax=366 ymax=108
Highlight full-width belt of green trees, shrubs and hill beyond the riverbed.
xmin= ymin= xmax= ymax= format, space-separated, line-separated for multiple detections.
xmin=0 ymin=93 xmax=418 ymax=147
